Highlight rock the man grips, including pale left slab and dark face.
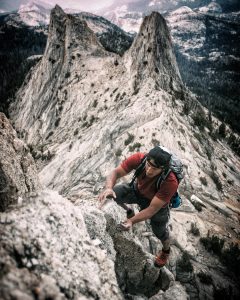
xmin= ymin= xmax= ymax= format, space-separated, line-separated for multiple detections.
xmin=75 ymin=200 xmax=174 ymax=297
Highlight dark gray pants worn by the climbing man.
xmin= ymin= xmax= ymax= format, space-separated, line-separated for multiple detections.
xmin=113 ymin=184 xmax=170 ymax=242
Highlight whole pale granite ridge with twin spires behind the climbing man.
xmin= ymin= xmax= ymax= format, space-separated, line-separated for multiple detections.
xmin=3 ymin=7 xmax=239 ymax=299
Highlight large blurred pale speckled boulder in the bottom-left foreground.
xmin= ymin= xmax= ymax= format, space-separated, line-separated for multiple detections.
xmin=0 ymin=191 xmax=123 ymax=300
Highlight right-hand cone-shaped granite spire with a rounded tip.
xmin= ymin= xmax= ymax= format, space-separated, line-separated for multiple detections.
xmin=125 ymin=12 xmax=183 ymax=93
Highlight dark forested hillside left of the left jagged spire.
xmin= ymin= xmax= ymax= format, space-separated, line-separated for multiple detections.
xmin=0 ymin=17 xmax=47 ymax=114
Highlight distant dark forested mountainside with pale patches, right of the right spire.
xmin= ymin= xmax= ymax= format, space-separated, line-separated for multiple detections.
xmin=166 ymin=7 xmax=240 ymax=132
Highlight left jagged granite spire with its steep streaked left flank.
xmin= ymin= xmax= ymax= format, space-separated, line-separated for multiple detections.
xmin=9 ymin=6 xmax=110 ymax=142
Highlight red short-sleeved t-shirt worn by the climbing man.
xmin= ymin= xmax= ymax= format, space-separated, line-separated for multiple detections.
xmin=121 ymin=152 xmax=178 ymax=207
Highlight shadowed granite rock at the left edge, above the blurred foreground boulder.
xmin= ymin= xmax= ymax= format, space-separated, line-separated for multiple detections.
xmin=0 ymin=113 xmax=40 ymax=211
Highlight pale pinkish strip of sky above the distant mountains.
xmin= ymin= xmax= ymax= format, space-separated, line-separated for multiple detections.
xmin=0 ymin=0 xmax=136 ymax=11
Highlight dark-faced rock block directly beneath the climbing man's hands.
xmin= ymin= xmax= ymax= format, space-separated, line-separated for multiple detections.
xmin=101 ymin=201 xmax=174 ymax=297
